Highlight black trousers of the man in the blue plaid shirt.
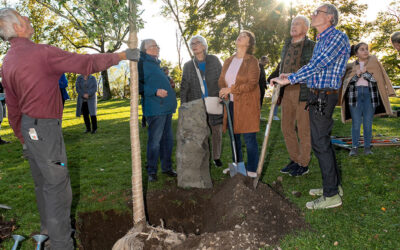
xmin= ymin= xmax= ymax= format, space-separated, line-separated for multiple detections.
xmin=309 ymin=93 xmax=340 ymax=197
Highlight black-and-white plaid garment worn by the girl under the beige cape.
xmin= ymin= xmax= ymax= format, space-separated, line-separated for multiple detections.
xmin=348 ymin=72 xmax=380 ymax=108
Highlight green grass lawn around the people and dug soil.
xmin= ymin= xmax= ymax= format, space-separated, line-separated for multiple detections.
xmin=0 ymin=98 xmax=400 ymax=249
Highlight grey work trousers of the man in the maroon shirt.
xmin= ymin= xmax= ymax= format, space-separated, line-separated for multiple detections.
xmin=21 ymin=115 xmax=74 ymax=250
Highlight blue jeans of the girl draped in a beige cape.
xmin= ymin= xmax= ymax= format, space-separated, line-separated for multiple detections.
xmin=350 ymin=86 xmax=375 ymax=148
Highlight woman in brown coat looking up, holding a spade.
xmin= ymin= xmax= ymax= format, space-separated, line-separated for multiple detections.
xmin=218 ymin=31 xmax=260 ymax=177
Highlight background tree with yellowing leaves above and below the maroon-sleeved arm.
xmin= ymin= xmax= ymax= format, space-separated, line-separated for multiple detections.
xmin=36 ymin=0 xmax=134 ymax=99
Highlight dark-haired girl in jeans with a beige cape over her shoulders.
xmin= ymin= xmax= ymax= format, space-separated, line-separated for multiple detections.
xmin=341 ymin=43 xmax=396 ymax=156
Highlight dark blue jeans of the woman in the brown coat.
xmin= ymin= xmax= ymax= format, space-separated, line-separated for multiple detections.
xmin=229 ymin=102 xmax=259 ymax=172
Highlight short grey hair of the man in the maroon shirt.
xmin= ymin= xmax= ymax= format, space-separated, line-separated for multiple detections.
xmin=0 ymin=8 xmax=21 ymax=41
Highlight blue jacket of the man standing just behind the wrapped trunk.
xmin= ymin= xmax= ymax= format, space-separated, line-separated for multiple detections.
xmin=138 ymin=53 xmax=177 ymax=116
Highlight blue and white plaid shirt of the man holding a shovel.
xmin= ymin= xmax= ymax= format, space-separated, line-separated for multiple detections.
xmin=288 ymin=26 xmax=350 ymax=89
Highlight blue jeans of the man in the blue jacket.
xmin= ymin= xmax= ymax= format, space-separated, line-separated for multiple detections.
xmin=146 ymin=114 xmax=174 ymax=174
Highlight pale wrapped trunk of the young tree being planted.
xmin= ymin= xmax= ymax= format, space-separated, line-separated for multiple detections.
xmin=128 ymin=0 xmax=146 ymax=226
